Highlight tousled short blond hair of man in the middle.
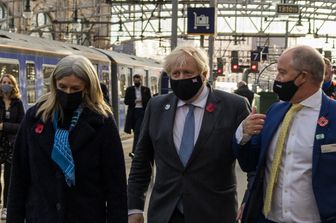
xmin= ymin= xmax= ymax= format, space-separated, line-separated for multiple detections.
xmin=163 ymin=45 xmax=209 ymax=76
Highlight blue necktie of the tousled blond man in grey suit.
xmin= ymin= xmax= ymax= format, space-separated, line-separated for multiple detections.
xmin=179 ymin=104 xmax=195 ymax=166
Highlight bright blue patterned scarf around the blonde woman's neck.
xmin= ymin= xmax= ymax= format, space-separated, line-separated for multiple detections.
xmin=51 ymin=106 xmax=83 ymax=187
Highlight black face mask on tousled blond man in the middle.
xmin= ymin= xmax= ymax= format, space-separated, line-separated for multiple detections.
xmin=170 ymin=75 xmax=203 ymax=101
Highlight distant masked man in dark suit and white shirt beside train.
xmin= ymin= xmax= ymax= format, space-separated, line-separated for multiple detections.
xmin=124 ymin=74 xmax=151 ymax=158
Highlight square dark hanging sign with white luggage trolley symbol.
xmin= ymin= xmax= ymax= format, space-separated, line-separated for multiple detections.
xmin=188 ymin=7 xmax=215 ymax=35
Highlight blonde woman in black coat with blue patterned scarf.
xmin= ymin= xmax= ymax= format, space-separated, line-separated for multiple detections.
xmin=7 ymin=55 xmax=127 ymax=223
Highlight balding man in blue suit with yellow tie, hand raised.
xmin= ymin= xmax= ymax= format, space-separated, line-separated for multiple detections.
xmin=236 ymin=46 xmax=336 ymax=223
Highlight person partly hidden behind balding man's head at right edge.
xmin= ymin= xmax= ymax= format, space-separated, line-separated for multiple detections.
xmin=322 ymin=58 xmax=336 ymax=99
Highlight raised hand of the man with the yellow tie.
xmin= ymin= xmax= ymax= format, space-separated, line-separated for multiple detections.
xmin=243 ymin=107 xmax=266 ymax=135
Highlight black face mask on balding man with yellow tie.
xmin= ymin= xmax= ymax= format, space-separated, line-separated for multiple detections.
xmin=273 ymin=73 xmax=301 ymax=101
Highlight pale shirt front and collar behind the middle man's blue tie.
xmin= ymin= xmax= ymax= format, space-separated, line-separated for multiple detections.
xmin=173 ymin=86 xmax=209 ymax=153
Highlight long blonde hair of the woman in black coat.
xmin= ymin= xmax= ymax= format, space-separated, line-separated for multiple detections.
xmin=36 ymin=55 xmax=112 ymax=122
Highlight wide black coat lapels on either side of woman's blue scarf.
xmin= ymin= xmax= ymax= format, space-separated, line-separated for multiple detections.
xmin=32 ymin=109 xmax=104 ymax=157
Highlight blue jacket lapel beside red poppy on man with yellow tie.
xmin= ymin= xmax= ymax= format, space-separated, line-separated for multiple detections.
xmin=312 ymin=94 xmax=335 ymax=177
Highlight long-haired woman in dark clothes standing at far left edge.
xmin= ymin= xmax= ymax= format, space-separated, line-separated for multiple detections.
xmin=0 ymin=74 xmax=24 ymax=220
